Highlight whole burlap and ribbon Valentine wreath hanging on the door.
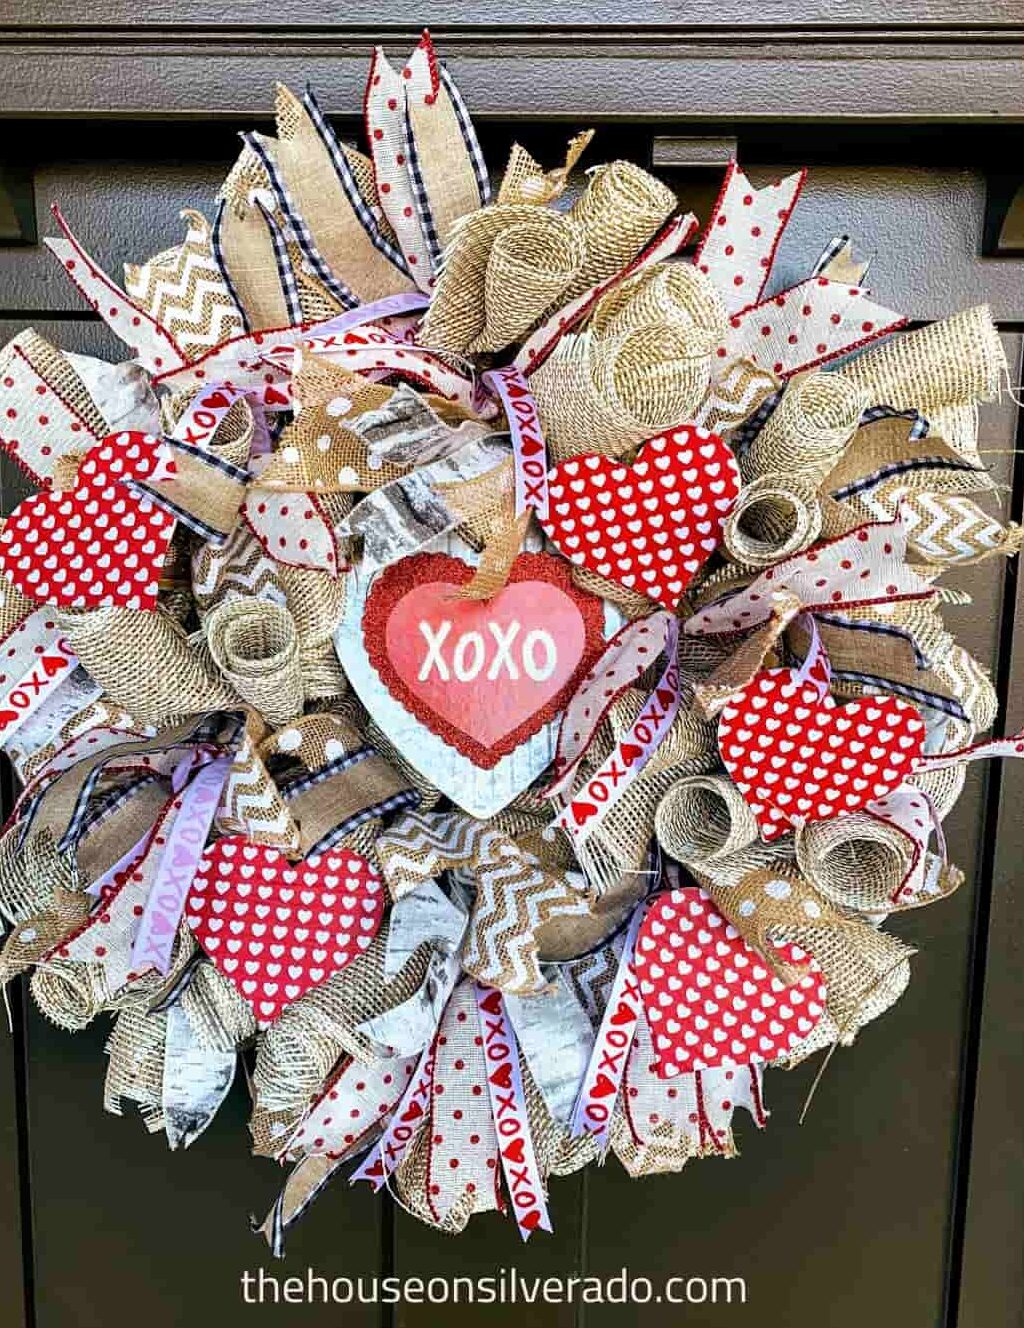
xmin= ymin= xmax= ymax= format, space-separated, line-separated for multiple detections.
xmin=0 ymin=35 xmax=1024 ymax=1252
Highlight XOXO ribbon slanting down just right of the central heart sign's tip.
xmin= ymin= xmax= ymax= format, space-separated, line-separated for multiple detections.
xmin=545 ymin=618 xmax=683 ymax=845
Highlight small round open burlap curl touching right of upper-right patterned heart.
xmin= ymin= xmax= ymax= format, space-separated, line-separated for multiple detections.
xmin=723 ymin=473 xmax=822 ymax=568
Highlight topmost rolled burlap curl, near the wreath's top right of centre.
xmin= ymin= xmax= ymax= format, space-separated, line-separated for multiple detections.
xmin=562 ymin=162 xmax=676 ymax=303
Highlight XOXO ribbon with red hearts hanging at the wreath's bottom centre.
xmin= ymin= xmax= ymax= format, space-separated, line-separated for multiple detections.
xmin=474 ymin=983 xmax=554 ymax=1240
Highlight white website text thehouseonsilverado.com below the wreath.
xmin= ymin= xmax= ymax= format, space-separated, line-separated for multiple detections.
xmin=240 ymin=1268 xmax=746 ymax=1305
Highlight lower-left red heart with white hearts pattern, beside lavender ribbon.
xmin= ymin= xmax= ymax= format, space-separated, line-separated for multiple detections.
xmin=185 ymin=835 xmax=384 ymax=1028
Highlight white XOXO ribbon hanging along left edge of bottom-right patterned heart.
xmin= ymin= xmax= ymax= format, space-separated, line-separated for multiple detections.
xmin=568 ymin=903 xmax=647 ymax=1151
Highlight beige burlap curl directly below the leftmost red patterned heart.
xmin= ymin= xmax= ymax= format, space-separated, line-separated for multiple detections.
xmin=57 ymin=608 xmax=239 ymax=725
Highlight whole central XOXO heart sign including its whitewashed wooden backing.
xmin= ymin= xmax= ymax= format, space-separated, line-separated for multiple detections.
xmin=335 ymin=535 xmax=622 ymax=819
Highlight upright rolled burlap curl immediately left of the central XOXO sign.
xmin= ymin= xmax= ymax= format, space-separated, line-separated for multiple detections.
xmin=205 ymin=599 xmax=304 ymax=726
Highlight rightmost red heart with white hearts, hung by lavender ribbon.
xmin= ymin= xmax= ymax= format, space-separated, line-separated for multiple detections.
xmin=719 ymin=668 xmax=924 ymax=839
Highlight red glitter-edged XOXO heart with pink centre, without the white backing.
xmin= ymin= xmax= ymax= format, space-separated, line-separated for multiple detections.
xmin=363 ymin=554 xmax=604 ymax=770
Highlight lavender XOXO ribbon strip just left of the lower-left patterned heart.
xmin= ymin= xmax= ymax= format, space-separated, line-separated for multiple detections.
xmin=131 ymin=757 xmax=231 ymax=973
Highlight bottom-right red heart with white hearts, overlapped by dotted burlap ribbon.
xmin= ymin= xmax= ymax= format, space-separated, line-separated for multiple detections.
xmin=634 ymin=887 xmax=826 ymax=1078
